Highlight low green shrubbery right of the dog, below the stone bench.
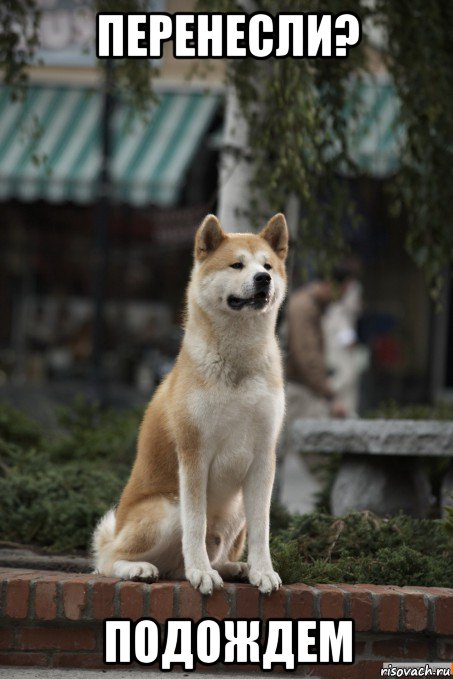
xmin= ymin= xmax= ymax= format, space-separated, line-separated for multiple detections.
xmin=271 ymin=512 xmax=453 ymax=587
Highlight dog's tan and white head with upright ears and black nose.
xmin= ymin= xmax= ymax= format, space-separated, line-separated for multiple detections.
xmin=192 ymin=214 xmax=288 ymax=314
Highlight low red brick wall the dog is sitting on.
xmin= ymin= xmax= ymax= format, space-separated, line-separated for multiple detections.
xmin=0 ymin=568 xmax=453 ymax=679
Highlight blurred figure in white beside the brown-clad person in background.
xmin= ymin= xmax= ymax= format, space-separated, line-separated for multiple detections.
xmin=323 ymin=279 xmax=368 ymax=417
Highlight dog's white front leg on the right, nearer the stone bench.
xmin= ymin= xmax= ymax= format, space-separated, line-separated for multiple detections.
xmin=244 ymin=449 xmax=282 ymax=594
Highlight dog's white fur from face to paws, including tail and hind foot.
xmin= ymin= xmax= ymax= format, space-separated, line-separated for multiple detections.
xmin=93 ymin=223 xmax=285 ymax=594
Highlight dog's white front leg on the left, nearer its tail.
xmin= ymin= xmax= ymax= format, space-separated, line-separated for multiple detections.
xmin=179 ymin=460 xmax=223 ymax=594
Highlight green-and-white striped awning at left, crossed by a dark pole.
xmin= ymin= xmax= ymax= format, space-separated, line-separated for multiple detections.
xmin=0 ymin=86 xmax=219 ymax=206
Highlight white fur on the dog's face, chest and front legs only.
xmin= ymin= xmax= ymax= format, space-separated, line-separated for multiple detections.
xmin=180 ymin=250 xmax=285 ymax=593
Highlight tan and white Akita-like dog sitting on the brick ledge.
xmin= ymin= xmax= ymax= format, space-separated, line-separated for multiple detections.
xmin=93 ymin=214 xmax=288 ymax=594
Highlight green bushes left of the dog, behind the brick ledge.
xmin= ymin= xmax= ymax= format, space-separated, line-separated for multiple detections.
xmin=0 ymin=399 xmax=140 ymax=551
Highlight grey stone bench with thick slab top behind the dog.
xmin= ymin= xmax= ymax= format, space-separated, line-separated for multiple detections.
xmin=290 ymin=419 xmax=453 ymax=517
